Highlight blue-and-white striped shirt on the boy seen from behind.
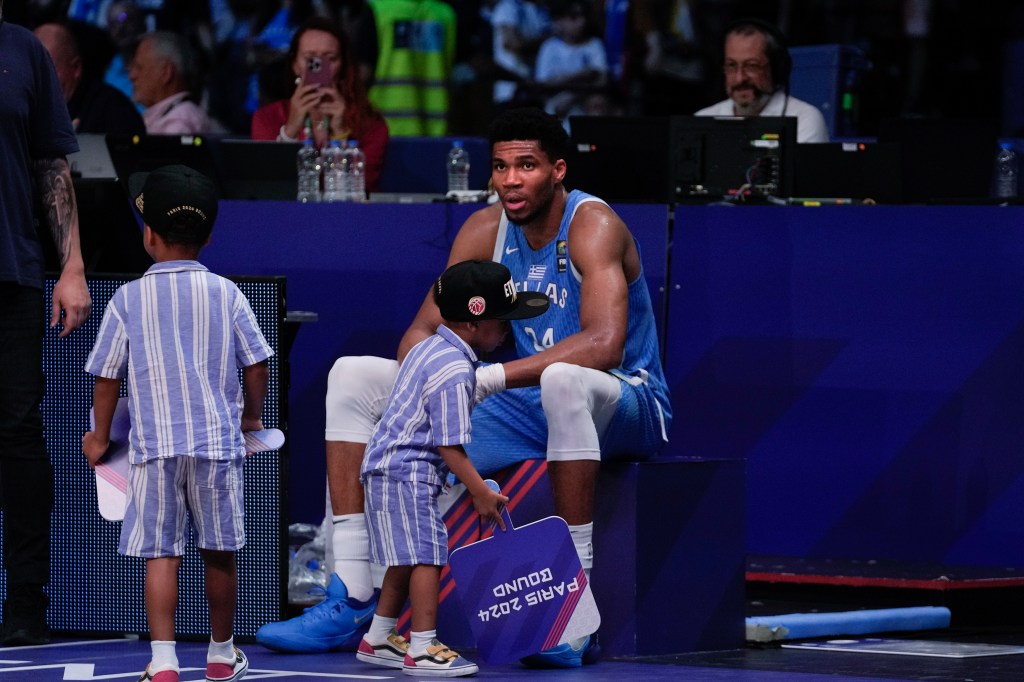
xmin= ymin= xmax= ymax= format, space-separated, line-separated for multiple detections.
xmin=85 ymin=260 xmax=273 ymax=464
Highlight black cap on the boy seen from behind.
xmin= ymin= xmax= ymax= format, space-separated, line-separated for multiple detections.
xmin=128 ymin=165 xmax=217 ymax=235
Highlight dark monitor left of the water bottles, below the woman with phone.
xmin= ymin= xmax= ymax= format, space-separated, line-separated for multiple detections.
xmin=213 ymin=138 xmax=300 ymax=201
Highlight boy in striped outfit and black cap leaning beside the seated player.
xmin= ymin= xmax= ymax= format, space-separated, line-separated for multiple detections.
xmin=355 ymin=260 xmax=548 ymax=677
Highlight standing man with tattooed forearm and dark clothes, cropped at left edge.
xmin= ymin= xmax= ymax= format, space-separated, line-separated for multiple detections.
xmin=0 ymin=0 xmax=91 ymax=646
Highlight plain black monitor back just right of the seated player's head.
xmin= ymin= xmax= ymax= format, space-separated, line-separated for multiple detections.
xmin=565 ymin=116 xmax=673 ymax=204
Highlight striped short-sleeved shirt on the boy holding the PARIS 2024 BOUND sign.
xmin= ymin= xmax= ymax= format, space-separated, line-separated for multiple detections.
xmin=362 ymin=325 xmax=476 ymax=485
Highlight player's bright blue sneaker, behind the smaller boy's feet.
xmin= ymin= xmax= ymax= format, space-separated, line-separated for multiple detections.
xmin=256 ymin=573 xmax=378 ymax=653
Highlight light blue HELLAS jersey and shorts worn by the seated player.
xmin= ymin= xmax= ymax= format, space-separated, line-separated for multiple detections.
xmin=467 ymin=190 xmax=672 ymax=473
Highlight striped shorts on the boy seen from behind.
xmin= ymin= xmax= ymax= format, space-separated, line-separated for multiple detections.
xmin=118 ymin=457 xmax=246 ymax=559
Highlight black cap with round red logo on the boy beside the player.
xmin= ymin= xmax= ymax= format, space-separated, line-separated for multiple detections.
xmin=434 ymin=260 xmax=548 ymax=322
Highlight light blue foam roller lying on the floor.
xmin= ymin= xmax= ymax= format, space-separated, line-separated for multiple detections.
xmin=746 ymin=606 xmax=950 ymax=642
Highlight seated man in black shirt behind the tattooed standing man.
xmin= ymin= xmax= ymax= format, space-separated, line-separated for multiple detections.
xmin=36 ymin=24 xmax=145 ymax=135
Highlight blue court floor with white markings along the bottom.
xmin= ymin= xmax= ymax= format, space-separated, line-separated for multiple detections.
xmin=0 ymin=632 xmax=1024 ymax=682
